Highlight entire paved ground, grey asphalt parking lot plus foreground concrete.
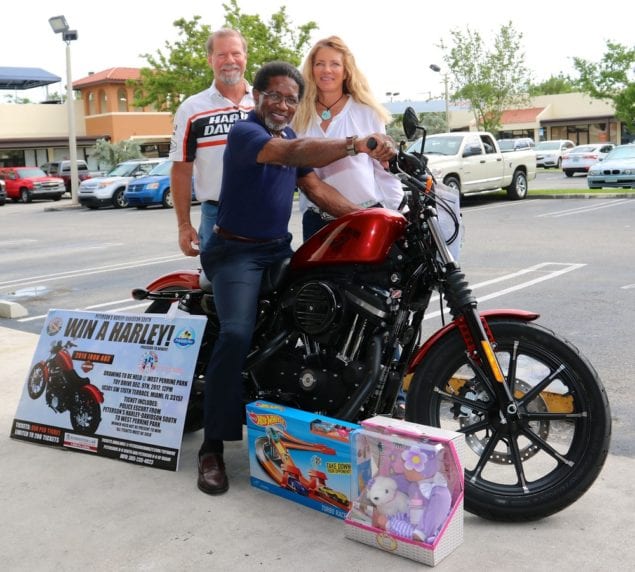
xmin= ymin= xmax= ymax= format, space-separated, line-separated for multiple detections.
xmin=0 ymin=185 xmax=635 ymax=571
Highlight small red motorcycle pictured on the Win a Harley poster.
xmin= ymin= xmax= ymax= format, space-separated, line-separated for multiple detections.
xmin=27 ymin=340 xmax=104 ymax=435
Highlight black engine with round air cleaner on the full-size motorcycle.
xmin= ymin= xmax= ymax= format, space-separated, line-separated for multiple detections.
xmin=252 ymin=280 xmax=392 ymax=414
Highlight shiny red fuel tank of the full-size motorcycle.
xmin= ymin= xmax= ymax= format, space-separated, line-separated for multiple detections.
xmin=291 ymin=208 xmax=406 ymax=269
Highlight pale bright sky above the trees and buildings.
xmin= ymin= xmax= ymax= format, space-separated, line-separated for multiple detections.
xmin=0 ymin=0 xmax=634 ymax=102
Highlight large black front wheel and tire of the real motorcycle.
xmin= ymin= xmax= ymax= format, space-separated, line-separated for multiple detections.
xmin=406 ymin=320 xmax=611 ymax=522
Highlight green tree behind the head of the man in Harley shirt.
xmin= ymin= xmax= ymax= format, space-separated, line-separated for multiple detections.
xmin=132 ymin=0 xmax=317 ymax=112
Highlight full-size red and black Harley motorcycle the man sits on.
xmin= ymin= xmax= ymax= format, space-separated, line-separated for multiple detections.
xmin=133 ymin=109 xmax=611 ymax=521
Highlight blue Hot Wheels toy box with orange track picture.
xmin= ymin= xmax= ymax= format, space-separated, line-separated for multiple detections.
xmin=247 ymin=401 xmax=359 ymax=519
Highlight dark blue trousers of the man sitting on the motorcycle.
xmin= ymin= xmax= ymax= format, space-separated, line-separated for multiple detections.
xmin=201 ymin=233 xmax=292 ymax=441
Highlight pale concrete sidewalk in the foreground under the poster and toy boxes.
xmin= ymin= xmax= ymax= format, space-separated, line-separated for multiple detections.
xmin=0 ymin=328 xmax=635 ymax=572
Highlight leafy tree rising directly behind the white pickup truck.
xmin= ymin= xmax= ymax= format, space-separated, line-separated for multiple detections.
xmin=440 ymin=22 xmax=529 ymax=131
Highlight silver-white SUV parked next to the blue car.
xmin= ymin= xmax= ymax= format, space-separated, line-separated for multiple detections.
xmin=78 ymin=159 xmax=167 ymax=209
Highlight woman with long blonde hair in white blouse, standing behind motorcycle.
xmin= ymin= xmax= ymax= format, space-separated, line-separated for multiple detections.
xmin=293 ymin=36 xmax=403 ymax=240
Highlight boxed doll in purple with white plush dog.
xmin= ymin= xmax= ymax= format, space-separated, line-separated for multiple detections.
xmin=345 ymin=417 xmax=465 ymax=566
